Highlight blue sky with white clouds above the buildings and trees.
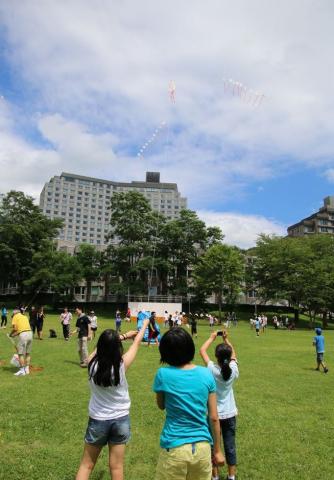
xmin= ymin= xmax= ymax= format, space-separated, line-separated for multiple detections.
xmin=0 ymin=0 xmax=334 ymax=247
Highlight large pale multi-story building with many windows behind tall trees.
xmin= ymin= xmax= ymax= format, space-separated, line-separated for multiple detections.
xmin=40 ymin=172 xmax=187 ymax=251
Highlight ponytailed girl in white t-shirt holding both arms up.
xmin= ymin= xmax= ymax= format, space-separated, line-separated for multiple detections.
xmin=200 ymin=331 xmax=239 ymax=480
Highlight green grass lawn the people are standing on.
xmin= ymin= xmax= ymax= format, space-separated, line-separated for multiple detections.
xmin=0 ymin=315 xmax=334 ymax=480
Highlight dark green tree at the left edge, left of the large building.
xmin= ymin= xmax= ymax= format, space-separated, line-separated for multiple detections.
xmin=0 ymin=191 xmax=62 ymax=295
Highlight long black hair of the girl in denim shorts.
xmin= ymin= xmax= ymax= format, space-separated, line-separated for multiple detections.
xmin=88 ymin=329 xmax=123 ymax=387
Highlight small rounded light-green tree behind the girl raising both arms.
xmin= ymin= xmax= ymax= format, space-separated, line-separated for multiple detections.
xmin=194 ymin=244 xmax=245 ymax=319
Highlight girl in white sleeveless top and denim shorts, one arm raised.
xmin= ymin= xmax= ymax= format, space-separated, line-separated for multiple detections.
xmin=76 ymin=320 xmax=149 ymax=480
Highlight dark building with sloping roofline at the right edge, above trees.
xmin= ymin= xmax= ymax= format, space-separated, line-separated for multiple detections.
xmin=288 ymin=195 xmax=334 ymax=237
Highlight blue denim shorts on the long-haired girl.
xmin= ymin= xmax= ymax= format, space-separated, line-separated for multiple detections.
xmin=85 ymin=415 xmax=131 ymax=446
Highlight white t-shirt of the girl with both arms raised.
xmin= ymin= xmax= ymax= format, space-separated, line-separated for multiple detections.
xmin=208 ymin=360 xmax=239 ymax=419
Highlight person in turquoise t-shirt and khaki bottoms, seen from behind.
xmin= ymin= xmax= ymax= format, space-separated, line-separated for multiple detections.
xmin=153 ymin=327 xmax=225 ymax=480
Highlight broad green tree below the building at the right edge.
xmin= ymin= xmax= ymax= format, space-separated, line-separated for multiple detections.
xmin=252 ymin=235 xmax=334 ymax=326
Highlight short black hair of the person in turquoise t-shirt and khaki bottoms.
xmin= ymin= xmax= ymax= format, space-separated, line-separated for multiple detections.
xmin=159 ymin=327 xmax=195 ymax=367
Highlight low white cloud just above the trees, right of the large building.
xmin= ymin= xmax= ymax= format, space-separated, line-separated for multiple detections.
xmin=198 ymin=210 xmax=286 ymax=248
